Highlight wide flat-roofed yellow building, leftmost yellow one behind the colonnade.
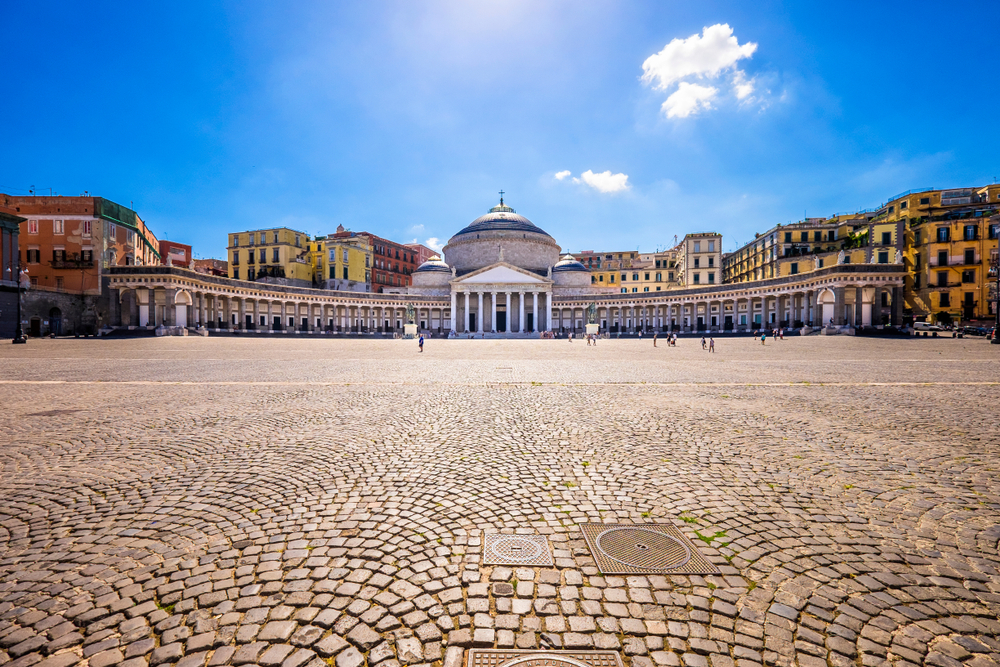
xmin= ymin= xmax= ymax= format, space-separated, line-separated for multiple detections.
xmin=229 ymin=227 xmax=313 ymax=287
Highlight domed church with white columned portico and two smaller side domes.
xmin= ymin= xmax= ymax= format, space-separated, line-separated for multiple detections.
xmin=401 ymin=197 xmax=604 ymax=333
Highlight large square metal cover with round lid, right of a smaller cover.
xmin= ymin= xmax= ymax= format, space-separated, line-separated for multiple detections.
xmin=580 ymin=523 xmax=719 ymax=574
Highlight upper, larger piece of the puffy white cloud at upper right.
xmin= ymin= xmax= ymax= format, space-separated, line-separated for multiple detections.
xmin=642 ymin=23 xmax=757 ymax=90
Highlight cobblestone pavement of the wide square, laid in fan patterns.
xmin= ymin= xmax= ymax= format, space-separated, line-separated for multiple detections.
xmin=0 ymin=337 xmax=1000 ymax=667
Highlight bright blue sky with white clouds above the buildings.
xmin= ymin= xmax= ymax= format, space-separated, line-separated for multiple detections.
xmin=0 ymin=0 xmax=1000 ymax=257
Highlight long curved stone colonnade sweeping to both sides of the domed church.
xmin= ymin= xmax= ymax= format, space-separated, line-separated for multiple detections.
xmin=104 ymin=264 xmax=905 ymax=334
